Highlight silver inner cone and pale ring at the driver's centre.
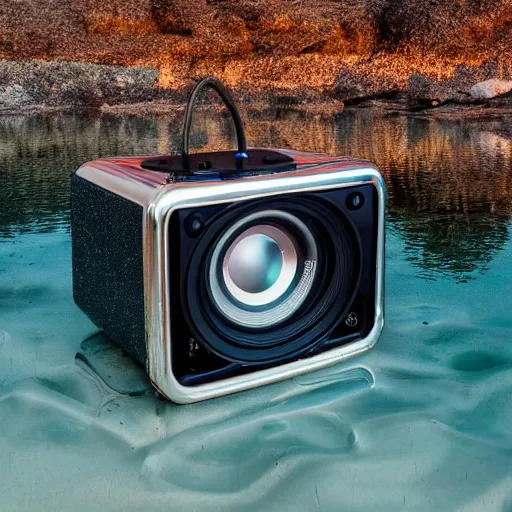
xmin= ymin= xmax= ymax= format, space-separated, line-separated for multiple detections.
xmin=209 ymin=210 xmax=317 ymax=329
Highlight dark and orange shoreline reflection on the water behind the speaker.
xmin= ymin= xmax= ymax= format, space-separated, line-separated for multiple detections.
xmin=0 ymin=110 xmax=512 ymax=280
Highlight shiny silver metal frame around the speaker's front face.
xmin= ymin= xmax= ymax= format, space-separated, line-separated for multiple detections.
xmin=143 ymin=162 xmax=386 ymax=404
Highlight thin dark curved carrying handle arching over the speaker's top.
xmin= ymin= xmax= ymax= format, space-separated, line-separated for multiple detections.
xmin=181 ymin=77 xmax=248 ymax=173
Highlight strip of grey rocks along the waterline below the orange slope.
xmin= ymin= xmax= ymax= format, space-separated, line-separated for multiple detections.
xmin=0 ymin=60 xmax=512 ymax=114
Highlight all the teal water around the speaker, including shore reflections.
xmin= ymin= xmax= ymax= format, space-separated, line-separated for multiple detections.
xmin=0 ymin=110 xmax=512 ymax=511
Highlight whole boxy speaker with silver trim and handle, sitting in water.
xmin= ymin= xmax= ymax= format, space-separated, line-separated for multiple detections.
xmin=71 ymin=78 xmax=386 ymax=403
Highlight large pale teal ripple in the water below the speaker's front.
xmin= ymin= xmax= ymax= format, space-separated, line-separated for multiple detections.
xmin=141 ymin=410 xmax=356 ymax=493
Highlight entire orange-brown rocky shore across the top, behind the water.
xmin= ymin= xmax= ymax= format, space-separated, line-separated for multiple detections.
xmin=0 ymin=0 xmax=512 ymax=113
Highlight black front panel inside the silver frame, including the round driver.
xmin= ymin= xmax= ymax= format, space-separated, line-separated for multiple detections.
xmin=167 ymin=184 xmax=378 ymax=386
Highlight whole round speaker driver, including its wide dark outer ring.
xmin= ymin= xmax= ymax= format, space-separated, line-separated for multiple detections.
xmin=183 ymin=195 xmax=361 ymax=365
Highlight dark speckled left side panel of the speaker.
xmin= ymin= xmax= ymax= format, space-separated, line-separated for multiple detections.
xmin=71 ymin=174 xmax=147 ymax=365
